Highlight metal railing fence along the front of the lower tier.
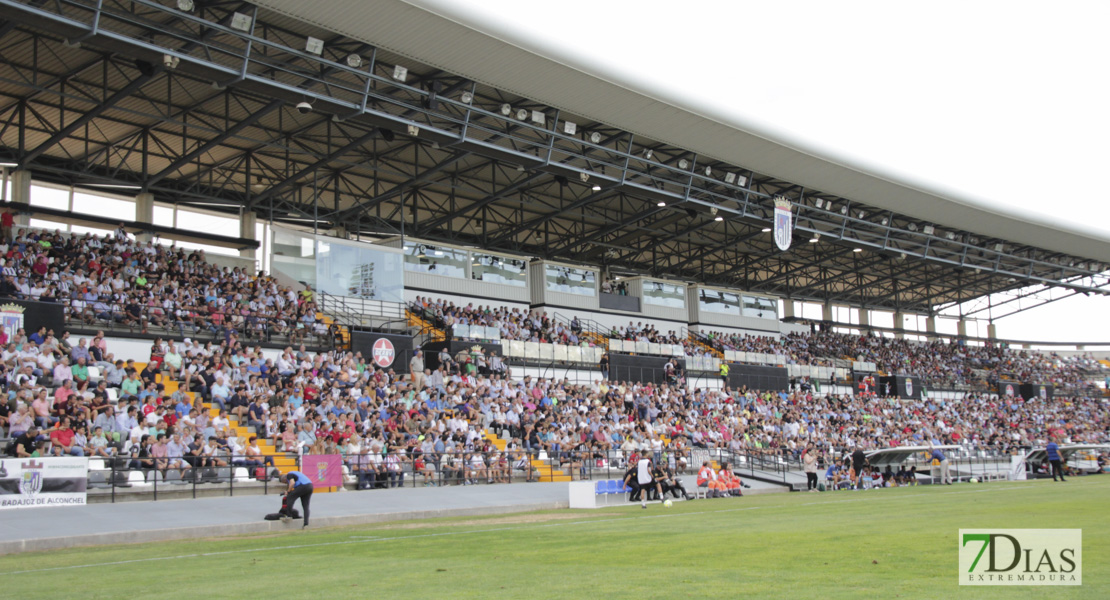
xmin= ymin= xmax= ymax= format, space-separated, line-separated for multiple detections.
xmin=76 ymin=444 xmax=1047 ymax=502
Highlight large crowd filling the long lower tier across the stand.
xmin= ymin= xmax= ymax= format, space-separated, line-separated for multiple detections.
xmin=0 ymin=308 xmax=1110 ymax=487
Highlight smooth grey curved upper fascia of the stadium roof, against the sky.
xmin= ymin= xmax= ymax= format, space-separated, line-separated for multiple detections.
xmin=259 ymin=0 xmax=1110 ymax=262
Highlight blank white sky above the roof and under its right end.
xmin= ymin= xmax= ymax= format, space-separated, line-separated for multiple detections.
xmin=417 ymin=0 xmax=1110 ymax=343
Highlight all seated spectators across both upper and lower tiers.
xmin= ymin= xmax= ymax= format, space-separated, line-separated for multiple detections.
xmin=0 ymin=231 xmax=1110 ymax=487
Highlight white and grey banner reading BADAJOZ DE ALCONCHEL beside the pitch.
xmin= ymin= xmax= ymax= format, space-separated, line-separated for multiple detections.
xmin=0 ymin=457 xmax=89 ymax=509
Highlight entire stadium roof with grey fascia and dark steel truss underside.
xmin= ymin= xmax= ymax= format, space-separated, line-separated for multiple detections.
xmin=0 ymin=0 xmax=1110 ymax=312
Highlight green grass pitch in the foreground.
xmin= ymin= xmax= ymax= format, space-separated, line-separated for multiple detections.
xmin=0 ymin=476 xmax=1110 ymax=600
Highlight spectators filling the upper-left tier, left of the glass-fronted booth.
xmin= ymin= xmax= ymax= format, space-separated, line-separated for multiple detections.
xmin=0 ymin=225 xmax=330 ymax=343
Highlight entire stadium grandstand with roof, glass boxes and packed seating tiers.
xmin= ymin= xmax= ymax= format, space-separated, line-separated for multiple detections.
xmin=0 ymin=0 xmax=1110 ymax=514
